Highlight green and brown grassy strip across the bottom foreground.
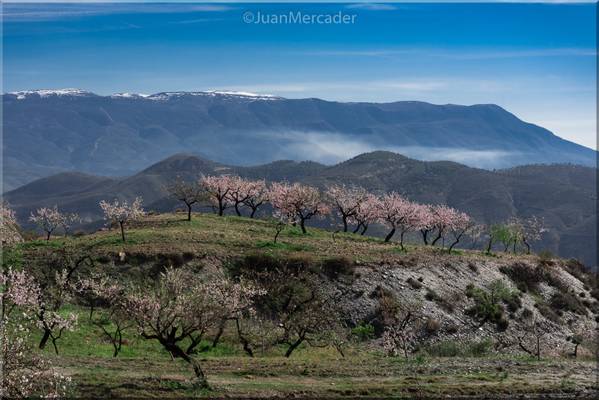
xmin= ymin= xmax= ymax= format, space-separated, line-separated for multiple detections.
xmin=44 ymin=310 xmax=597 ymax=398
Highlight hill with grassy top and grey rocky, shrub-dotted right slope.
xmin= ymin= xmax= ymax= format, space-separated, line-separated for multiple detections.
xmin=14 ymin=214 xmax=599 ymax=355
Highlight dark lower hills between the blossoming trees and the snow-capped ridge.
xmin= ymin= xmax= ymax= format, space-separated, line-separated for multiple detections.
xmin=5 ymin=151 xmax=597 ymax=265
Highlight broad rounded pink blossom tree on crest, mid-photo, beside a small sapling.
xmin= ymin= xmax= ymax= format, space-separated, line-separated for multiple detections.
xmin=269 ymin=182 xmax=331 ymax=234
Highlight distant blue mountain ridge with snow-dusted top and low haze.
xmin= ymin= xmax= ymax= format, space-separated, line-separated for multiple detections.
xmin=2 ymin=89 xmax=596 ymax=190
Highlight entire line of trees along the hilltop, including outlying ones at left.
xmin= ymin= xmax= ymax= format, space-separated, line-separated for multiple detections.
xmin=7 ymin=175 xmax=546 ymax=253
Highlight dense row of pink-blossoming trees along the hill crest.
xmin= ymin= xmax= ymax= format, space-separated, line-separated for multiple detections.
xmin=195 ymin=176 xmax=473 ymax=251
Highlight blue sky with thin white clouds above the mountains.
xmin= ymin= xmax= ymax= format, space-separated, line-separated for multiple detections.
xmin=3 ymin=2 xmax=597 ymax=148
